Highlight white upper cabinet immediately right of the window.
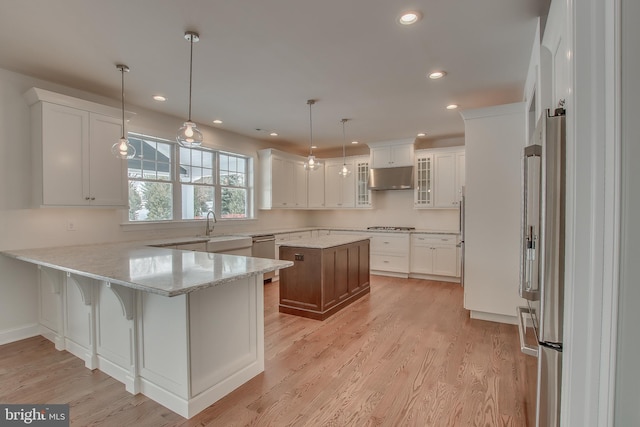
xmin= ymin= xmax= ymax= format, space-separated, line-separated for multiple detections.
xmin=258 ymin=149 xmax=307 ymax=209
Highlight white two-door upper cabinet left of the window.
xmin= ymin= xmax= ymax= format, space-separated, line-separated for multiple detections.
xmin=25 ymin=88 xmax=128 ymax=208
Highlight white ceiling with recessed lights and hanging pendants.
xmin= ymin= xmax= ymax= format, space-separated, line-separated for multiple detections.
xmin=0 ymin=0 xmax=549 ymax=151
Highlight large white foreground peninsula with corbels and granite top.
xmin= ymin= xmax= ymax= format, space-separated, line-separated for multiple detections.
xmin=2 ymin=243 xmax=293 ymax=418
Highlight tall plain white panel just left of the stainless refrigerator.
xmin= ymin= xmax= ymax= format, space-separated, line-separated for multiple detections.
xmin=463 ymin=102 xmax=527 ymax=323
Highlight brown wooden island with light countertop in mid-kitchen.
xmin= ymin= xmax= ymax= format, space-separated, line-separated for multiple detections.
xmin=279 ymin=236 xmax=370 ymax=320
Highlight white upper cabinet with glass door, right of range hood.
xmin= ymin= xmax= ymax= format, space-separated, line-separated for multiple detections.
xmin=414 ymin=148 xmax=465 ymax=208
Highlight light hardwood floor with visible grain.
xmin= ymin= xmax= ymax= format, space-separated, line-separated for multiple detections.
xmin=0 ymin=276 xmax=535 ymax=427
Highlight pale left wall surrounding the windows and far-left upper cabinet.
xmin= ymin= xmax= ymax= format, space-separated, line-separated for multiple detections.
xmin=0 ymin=65 xmax=309 ymax=343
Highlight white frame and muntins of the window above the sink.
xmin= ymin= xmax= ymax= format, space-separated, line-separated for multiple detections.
xmin=125 ymin=132 xmax=256 ymax=225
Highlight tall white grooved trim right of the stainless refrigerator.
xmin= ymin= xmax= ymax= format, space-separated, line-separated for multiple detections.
xmin=561 ymin=0 xmax=620 ymax=427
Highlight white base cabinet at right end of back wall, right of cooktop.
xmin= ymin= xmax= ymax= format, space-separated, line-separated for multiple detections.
xmin=410 ymin=234 xmax=459 ymax=277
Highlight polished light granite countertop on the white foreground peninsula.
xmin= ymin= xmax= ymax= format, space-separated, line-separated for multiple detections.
xmin=2 ymin=243 xmax=293 ymax=297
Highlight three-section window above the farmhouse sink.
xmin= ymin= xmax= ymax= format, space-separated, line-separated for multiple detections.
xmin=128 ymin=133 xmax=252 ymax=222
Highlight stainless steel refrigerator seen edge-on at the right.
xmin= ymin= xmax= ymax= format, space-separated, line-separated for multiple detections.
xmin=517 ymin=109 xmax=566 ymax=427
